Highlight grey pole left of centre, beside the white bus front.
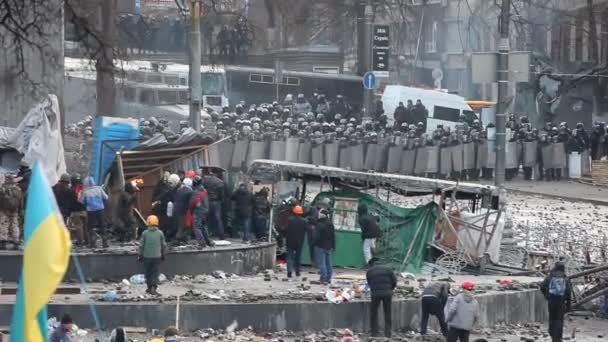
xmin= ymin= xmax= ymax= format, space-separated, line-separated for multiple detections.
xmin=190 ymin=0 xmax=203 ymax=132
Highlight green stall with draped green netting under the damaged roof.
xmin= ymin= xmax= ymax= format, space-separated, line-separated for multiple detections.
xmin=303 ymin=190 xmax=437 ymax=272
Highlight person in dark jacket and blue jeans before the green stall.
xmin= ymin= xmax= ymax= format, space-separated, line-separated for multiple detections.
xmin=315 ymin=209 xmax=336 ymax=285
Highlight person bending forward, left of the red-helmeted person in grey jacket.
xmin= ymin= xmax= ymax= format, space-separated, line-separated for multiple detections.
xmin=420 ymin=282 xmax=450 ymax=337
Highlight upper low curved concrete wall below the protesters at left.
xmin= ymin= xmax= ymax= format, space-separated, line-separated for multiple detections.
xmin=0 ymin=243 xmax=276 ymax=282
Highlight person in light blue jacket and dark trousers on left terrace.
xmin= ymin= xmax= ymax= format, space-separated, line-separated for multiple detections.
xmin=79 ymin=176 xmax=108 ymax=248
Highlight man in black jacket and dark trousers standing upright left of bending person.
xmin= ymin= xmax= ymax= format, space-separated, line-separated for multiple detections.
xmin=365 ymin=257 xmax=397 ymax=338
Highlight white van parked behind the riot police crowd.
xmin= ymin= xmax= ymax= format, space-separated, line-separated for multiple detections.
xmin=382 ymin=85 xmax=475 ymax=133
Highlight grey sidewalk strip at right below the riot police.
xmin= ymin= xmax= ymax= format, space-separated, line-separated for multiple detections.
xmin=481 ymin=179 xmax=608 ymax=205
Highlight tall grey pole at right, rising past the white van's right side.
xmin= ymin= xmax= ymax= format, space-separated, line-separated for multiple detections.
xmin=495 ymin=0 xmax=511 ymax=188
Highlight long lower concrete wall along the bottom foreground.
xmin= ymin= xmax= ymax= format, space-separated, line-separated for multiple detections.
xmin=0 ymin=290 xmax=547 ymax=332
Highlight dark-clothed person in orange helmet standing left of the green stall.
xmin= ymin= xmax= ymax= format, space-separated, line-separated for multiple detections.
xmin=285 ymin=205 xmax=307 ymax=279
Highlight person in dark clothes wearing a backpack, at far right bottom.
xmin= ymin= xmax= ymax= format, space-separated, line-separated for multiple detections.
xmin=540 ymin=261 xmax=572 ymax=342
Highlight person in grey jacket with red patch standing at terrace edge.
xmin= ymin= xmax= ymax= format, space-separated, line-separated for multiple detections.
xmin=186 ymin=176 xmax=215 ymax=248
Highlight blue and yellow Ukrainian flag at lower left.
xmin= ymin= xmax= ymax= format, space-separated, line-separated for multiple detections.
xmin=10 ymin=162 xmax=71 ymax=342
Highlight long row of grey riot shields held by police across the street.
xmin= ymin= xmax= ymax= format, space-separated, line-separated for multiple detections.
xmin=209 ymin=132 xmax=590 ymax=181
